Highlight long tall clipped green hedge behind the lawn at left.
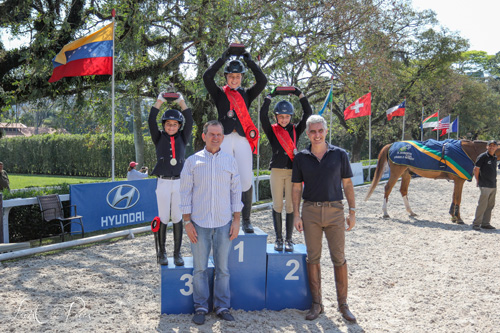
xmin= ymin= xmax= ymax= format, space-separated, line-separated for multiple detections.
xmin=0 ymin=134 xmax=156 ymax=177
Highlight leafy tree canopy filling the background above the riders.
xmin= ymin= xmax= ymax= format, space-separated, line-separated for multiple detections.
xmin=0 ymin=0 xmax=500 ymax=160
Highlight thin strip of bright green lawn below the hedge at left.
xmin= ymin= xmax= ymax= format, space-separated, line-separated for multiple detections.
xmin=9 ymin=174 xmax=120 ymax=190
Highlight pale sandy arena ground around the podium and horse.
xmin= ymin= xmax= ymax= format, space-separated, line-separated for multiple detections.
xmin=0 ymin=178 xmax=500 ymax=332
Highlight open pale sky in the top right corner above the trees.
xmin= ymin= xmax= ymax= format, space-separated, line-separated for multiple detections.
xmin=413 ymin=0 xmax=500 ymax=55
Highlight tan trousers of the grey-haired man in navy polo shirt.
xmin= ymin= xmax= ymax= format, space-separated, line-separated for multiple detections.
xmin=302 ymin=201 xmax=345 ymax=266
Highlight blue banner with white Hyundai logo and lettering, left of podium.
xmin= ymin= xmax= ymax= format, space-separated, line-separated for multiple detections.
xmin=70 ymin=179 xmax=158 ymax=232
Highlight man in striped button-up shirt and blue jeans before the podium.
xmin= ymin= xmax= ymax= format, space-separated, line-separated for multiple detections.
xmin=180 ymin=120 xmax=243 ymax=325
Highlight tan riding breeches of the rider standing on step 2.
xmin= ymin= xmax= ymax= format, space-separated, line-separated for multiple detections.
xmin=271 ymin=168 xmax=293 ymax=214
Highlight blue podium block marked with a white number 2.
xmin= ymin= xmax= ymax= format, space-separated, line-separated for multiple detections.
xmin=266 ymin=244 xmax=312 ymax=311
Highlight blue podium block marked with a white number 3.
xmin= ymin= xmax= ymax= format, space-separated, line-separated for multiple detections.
xmin=160 ymin=257 xmax=214 ymax=314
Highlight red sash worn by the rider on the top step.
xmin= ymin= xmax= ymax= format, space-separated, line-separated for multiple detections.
xmin=223 ymin=84 xmax=259 ymax=154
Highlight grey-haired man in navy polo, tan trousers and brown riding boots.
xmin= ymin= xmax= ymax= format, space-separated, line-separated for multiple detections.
xmin=292 ymin=115 xmax=356 ymax=322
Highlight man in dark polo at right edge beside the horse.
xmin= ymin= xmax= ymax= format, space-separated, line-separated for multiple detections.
xmin=472 ymin=140 xmax=498 ymax=230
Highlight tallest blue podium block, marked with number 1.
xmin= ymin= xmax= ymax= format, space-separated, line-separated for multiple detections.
xmin=229 ymin=227 xmax=267 ymax=311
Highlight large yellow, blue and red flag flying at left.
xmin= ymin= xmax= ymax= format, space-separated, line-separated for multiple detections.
xmin=49 ymin=23 xmax=114 ymax=82
